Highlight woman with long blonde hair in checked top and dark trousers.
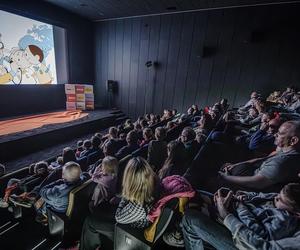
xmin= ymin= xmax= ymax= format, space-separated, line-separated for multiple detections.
xmin=80 ymin=157 xmax=159 ymax=250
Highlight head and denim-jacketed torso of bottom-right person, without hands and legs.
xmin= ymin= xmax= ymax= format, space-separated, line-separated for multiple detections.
xmin=233 ymin=183 xmax=300 ymax=240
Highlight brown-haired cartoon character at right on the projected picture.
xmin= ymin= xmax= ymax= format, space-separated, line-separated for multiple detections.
xmin=24 ymin=45 xmax=53 ymax=84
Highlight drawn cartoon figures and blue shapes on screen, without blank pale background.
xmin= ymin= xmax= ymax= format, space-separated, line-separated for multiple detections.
xmin=0 ymin=25 xmax=53 ymax=84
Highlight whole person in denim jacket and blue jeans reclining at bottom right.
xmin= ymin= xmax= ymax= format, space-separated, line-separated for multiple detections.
xmin=182 ymin=184 xmax=300 ymax=250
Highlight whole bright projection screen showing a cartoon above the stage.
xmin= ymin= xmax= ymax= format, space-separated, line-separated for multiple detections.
xmin=0 ymin=10 xmax=57 ymax=85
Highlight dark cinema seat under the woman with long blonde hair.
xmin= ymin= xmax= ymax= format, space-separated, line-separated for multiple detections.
xmin=114 ymin=198 xmax=178 ymax=250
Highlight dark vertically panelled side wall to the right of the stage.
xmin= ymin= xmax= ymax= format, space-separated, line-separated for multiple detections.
xmin=95 ymin=2 xmax=300 ymax=117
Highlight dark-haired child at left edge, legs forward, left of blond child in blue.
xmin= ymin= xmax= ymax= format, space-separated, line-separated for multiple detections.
xmin=0 ymin=161 xmax=48 ymax=208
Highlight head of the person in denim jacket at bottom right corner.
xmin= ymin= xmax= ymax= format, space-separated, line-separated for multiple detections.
xmin=274 ymin=183 xmax=300 ymax=216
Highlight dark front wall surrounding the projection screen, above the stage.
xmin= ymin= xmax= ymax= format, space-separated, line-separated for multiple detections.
xmin=0 ymin=0 xmax=95 ymax=117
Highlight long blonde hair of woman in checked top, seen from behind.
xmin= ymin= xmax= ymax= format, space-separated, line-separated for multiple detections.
xmin=122 ymin=157 xmax=157 ymax=205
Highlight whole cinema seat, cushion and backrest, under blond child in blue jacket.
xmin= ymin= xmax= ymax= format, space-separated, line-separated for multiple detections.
xmin=47 ymin=179 xmax=96 ymax=237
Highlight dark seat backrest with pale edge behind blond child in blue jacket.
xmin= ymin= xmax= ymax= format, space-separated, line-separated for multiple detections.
xmin=66 ymin=179 xmax=96 ymax=220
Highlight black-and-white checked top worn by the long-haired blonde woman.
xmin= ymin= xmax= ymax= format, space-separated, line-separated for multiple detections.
xmin=115 ymin=198 xmax=152 ymax=228
